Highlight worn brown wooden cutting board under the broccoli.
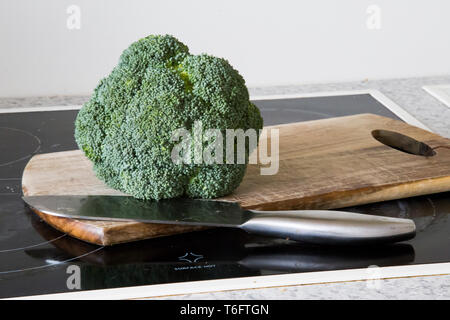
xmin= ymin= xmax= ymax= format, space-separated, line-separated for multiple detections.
xmin=22 ymin=114 xmax=450 ymax=245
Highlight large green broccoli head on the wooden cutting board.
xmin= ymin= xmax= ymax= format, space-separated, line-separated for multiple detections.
xmin=75 ymin=35 xmax=263 ymax=200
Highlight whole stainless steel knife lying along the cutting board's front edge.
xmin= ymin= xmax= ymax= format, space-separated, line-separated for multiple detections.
xmin=23 ymin=195 xmax=416 ymax=245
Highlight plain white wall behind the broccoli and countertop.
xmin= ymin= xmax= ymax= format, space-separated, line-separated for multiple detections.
xmin=0 ymin=0 xmax=450 ymax=97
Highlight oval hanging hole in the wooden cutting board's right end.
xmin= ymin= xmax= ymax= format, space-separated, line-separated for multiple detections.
xmin=372 ymin=130 xmax=436 ymax=157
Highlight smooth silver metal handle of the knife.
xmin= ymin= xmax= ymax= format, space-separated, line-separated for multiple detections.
xmin=240 ymin=210 xmax=416 ymax=245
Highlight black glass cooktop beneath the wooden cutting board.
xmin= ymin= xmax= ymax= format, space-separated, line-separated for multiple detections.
xmin=0 ymin=94 xmax=450 ymax=297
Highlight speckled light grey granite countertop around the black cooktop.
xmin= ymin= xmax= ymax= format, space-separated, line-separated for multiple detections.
xmin=0 ymin=76 xmax=450 ymax=299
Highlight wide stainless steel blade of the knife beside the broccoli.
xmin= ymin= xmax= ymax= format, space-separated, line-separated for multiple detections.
xmin=23 ymin=196 xmax=249 ymax=227
